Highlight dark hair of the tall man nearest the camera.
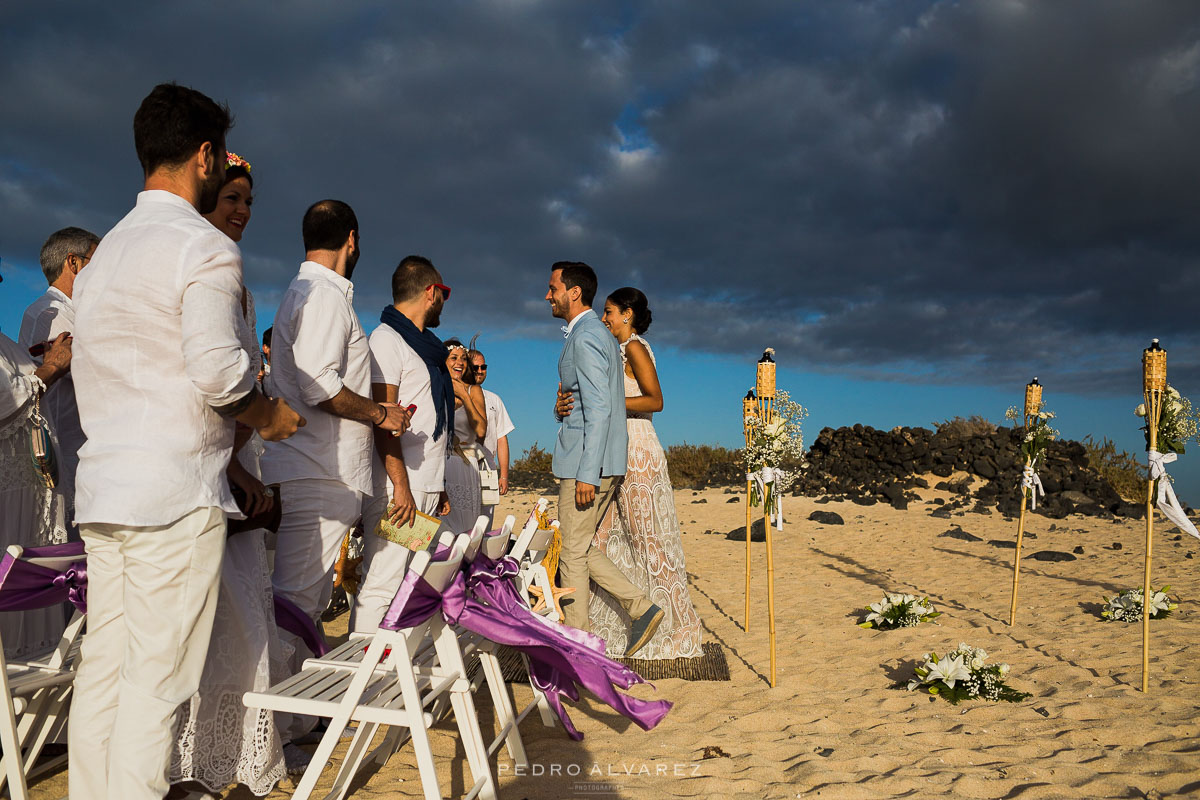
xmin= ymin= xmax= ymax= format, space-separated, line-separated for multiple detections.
xmin=133 ymin=83 xmax=233 ymax=176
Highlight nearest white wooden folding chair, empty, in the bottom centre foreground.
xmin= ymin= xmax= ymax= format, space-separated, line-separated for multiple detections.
xmin=244 ymin=535 xmax=497 ymax=800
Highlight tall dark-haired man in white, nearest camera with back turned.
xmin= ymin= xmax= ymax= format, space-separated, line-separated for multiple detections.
xmin=68 ymin=84 xmax=304 ymax=800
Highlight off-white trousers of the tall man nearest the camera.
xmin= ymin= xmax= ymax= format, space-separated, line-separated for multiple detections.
xmin=67 ymin=507 xmax=226 ymax=800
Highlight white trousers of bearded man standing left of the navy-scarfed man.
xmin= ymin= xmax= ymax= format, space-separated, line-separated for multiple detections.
xmin=271 ymin=479 xmax=362 ymax=633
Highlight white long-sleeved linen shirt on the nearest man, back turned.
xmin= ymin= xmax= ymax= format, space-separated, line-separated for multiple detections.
xmin=71 ymin=191 xmax=254 ymax=527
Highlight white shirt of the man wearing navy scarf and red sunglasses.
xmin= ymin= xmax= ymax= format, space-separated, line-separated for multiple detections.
xmin=371 ymin=324 xmax=454 ymax=499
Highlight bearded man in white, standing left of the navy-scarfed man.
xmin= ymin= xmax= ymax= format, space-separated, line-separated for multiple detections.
xmin=263 ymin=200 xmax=408 ymax=652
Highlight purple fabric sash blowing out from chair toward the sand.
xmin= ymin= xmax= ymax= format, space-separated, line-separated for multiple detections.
xmin=380 ymin=554 xmax=671 ymax=740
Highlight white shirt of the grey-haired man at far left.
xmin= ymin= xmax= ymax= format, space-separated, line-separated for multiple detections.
xmin=17 ymin=287 xmax=86 ymax=482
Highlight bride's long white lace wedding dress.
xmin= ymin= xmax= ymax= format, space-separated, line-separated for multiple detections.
xmin=588 ymin=333 xmax=702 ymax=660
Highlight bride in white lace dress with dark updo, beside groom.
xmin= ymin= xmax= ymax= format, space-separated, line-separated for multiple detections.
xmin=588 ymin=287 xmax=702 ymax=660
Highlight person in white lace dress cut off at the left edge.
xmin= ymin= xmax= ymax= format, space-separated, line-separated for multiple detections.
xmin=0 ymin=316 xmax=71 ymax=658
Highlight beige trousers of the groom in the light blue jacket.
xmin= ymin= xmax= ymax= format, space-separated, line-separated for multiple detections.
xmin=558 ymin=476 xmax=652 ymax=631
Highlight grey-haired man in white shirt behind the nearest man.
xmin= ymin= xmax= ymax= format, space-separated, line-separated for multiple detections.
xmin=17 ymin=228 xmax=100 ymax=521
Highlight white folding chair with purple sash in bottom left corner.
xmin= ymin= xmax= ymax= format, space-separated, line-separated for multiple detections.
xmin=0 ymin=545 xmax=84 ymax=800
